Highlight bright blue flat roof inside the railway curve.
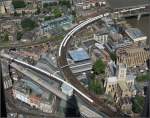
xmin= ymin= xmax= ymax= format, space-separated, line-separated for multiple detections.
xmin=69 ymin=48 xmax=90 ymax=61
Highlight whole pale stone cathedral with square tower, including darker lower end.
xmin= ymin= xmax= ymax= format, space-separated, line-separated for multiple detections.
xmin=104 ymin=63 xmax=136 ymax=112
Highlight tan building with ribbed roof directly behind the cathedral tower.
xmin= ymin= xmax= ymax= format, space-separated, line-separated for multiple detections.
xmin=116 ymin=47 xmax=150 ymax=67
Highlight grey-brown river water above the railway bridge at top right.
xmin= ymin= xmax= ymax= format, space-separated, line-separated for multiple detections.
xmin=108 ymin=0 xmax=150 ymax=9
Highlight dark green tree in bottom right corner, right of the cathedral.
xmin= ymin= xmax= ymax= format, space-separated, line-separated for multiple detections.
xmin=132 ymin=95 xmax=144 ymax=113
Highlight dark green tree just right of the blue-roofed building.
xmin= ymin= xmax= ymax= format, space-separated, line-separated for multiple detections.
xmin=93 ymin=59 xmax=106 ymax=75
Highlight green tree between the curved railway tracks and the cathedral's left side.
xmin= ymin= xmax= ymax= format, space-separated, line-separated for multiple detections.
xmin=89 ymin=79 xmax=104 ymax=94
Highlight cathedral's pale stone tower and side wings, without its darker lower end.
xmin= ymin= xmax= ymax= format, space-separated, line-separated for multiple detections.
xmin=105 ymin=64 xmax=136 ymax=97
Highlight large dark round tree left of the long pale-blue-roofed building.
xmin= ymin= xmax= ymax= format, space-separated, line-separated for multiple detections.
xmin=21 ymin=18 xmax=37 ymax=31
